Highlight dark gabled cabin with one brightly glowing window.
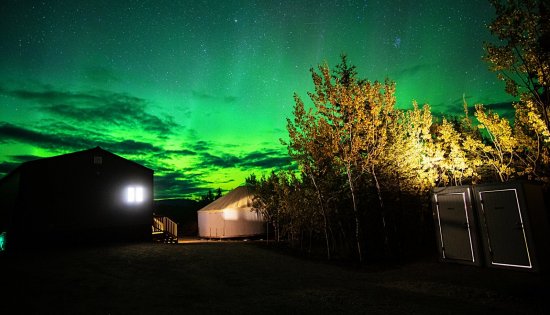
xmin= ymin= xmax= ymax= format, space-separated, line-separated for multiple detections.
xmin=0 ymin=147 xmax=153 ymax=250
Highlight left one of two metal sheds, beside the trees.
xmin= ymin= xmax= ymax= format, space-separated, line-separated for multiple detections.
xmin=432 ymin=186 xmax=482 ymax=266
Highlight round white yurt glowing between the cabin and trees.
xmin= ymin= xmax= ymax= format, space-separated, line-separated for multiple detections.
xmin=197 ymin=186 xmax=265 ymax=238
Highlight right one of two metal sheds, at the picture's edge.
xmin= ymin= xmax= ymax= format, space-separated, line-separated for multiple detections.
xmin=473 ymin=181 xmax=550 ymax=271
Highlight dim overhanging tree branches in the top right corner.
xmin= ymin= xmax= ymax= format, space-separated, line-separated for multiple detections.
xmin=484 ymin=0 xmax=550 ymax=128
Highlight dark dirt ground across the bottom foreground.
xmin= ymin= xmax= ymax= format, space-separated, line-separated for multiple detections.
xmin=0 ymin=241 xmax=550 ymax=314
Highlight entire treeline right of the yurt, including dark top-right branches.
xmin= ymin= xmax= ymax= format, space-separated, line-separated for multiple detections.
xmin=247 ymin=0 xmax=550 ymax=262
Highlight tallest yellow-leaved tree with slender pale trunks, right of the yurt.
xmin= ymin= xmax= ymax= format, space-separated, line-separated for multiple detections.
xmin=309 ymin=56 xmax=404 ymax=261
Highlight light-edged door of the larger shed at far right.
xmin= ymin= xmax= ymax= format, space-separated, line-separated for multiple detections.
xmin=479 ymin=189 xmax=532 ymax=268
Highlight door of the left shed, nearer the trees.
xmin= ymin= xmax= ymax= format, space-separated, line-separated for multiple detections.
xmin=435 ymin=193 xmax=474 ymax=262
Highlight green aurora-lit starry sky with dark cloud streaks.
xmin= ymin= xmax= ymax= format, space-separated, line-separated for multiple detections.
xmin=0 ymin=0 xmax=511 ymax=199
